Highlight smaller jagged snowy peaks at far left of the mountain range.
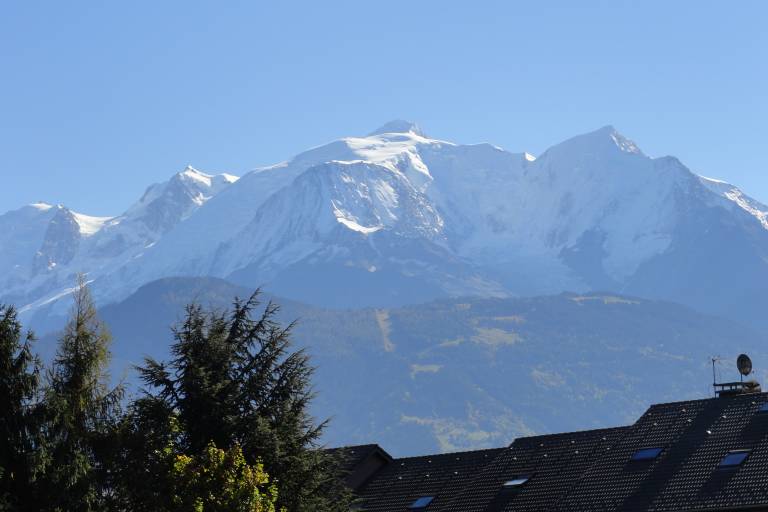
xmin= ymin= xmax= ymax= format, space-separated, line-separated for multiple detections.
xmin=0 ymin=167 xmax=237 ymax=324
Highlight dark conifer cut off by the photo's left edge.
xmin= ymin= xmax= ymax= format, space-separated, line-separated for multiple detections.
xmin=0 ymin=305 xmax=41 ymax=510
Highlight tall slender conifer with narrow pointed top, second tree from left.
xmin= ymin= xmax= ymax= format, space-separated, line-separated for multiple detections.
xmin=39 ymin=277 xmax=122 ymax=511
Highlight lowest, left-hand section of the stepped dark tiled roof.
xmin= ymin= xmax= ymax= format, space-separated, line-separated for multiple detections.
xmin=359 ymin=448 xmax=504 ymax=512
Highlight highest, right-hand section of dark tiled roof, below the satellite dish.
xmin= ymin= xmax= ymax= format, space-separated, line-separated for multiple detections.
xmin=559 ymin=394 xmax=768 ymax=511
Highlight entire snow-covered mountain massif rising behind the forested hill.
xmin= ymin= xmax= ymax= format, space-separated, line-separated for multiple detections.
xmin=0 ymin=121 xmax=768 ymax=328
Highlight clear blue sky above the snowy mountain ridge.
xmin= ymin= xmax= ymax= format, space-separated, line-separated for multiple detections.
xmin=0 ymin=0 xmax=768 ymax=215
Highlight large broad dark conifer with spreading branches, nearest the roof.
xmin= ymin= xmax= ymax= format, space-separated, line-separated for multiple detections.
xmin=140 ymin=292 xmax=350 ymax=512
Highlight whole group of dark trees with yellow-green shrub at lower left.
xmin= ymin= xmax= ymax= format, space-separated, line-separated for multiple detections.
xmin=0 ymin=282 xmax=351 ymax=512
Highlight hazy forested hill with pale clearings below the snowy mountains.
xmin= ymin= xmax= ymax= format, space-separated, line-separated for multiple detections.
xmin=41 ymin=278 xmax=768 ymax=454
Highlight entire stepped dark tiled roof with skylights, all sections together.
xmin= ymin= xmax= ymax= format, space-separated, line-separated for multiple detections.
xmin=342 ymin=393 xmax=768 ymax=512
